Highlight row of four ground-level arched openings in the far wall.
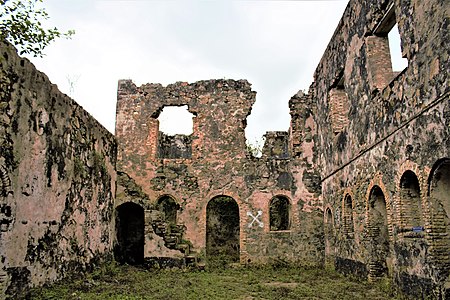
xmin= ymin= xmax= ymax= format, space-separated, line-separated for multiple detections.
xmin=115 ymin=195 xmax=291 ymax=264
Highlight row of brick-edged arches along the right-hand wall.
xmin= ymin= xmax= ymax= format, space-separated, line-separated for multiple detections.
xmin=325 ymin=158 xmax=450 ymax=276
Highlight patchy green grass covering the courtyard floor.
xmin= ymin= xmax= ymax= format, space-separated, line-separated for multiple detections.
xmin=29 ymin=264 xmax=403 ymax=300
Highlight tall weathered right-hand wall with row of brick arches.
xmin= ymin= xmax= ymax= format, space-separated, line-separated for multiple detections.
xmin=306 ymin=0 xmax=450 ymax=297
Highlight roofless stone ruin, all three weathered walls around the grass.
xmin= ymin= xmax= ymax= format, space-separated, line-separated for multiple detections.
xmin=0 ymin=0 xmax=450 ymax=299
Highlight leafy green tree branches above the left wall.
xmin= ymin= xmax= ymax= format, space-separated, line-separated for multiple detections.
xmin=0 ymin=0 xmax=75 ymax=57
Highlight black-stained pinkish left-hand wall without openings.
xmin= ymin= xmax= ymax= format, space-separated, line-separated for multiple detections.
xmin=0 ymin=43 xmax=117 ymax=298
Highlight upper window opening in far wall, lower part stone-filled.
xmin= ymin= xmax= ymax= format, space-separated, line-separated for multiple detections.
xmin=158 ymin=105 xmax=194 ymax=159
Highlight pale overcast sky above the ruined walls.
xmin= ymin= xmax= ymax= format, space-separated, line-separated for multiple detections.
xmin=31 ymin=0 xmax=348 ymax=144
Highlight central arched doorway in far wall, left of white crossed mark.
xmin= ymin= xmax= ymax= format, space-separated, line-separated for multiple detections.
xmin=206 ymin=196 xmax=240 ymax=262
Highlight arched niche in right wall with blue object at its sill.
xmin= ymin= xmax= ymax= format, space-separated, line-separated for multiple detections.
xmin=400 ymin=171 xmax=424 ymax=228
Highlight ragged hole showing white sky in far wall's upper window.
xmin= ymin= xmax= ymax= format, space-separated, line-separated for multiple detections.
xmin=158 ymin=105 xmax=195 ymax=135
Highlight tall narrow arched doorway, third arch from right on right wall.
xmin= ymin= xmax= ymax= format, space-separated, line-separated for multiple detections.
xmin=368 ymin=186 xmax=389 ymax=278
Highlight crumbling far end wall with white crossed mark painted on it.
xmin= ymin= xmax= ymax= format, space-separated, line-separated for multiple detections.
xmin=116 ymin=80 xmax=323 ymax=264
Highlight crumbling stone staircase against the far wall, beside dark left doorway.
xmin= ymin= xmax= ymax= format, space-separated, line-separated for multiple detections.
xmin=150 ymin=210 xmax=204 ymax=269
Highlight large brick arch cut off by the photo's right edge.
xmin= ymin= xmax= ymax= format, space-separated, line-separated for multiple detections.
xmin=427 ymin=158 xmax=450 ymax=278
